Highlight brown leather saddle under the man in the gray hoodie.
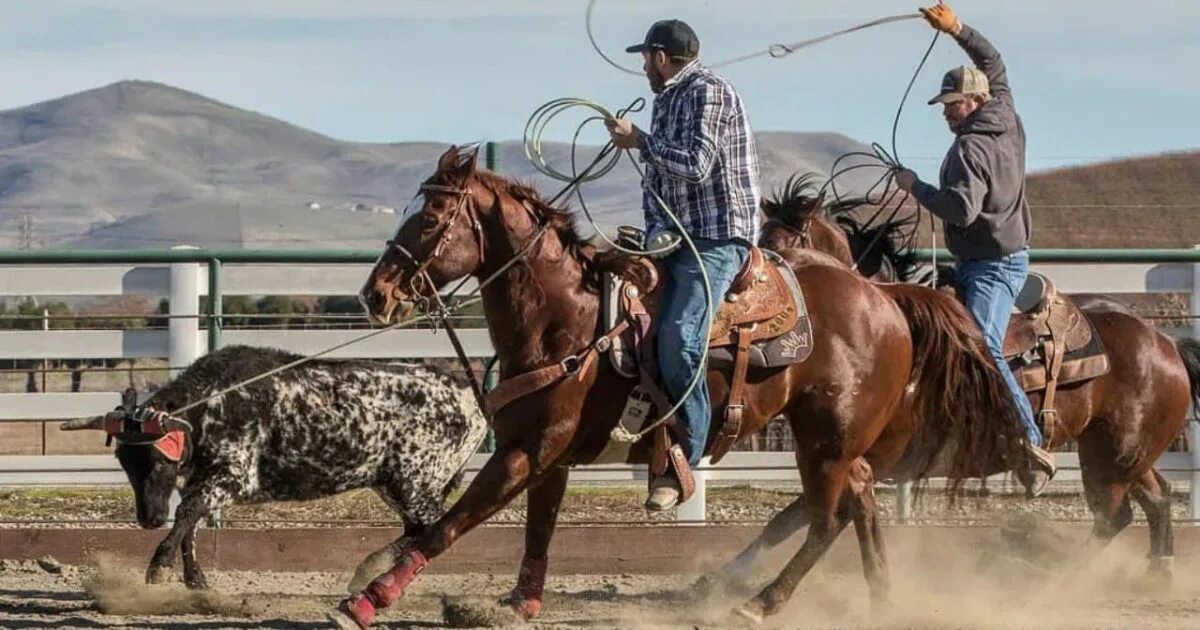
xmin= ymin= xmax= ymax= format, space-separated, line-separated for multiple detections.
xmin=1003 ymin=274 xmax=1109 ymax=439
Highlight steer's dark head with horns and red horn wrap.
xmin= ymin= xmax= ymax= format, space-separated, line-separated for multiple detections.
xmin=61 ymin=390 xmax=192 ymax=529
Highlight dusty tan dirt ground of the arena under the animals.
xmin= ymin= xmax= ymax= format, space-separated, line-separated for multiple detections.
xmin=0 ymin=516 xmax=1200 ymax=630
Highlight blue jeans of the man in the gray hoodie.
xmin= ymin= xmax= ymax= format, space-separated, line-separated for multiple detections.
xmin=954 ymin=250 xmax=1042 ymax=446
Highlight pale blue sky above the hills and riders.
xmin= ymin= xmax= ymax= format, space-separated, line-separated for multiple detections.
xmin=0 ymin=0 xmax=1200 ymax=175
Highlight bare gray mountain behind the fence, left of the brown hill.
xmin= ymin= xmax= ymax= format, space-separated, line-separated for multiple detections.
xmin=0 ymin=82 xmax=870 ymax=248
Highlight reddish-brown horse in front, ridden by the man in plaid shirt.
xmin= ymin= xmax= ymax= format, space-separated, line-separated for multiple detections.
xmin=335 ymin=148 xmax=1026 ymax=628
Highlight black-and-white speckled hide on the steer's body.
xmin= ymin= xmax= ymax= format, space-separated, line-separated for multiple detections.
xmin=142 ymin=346 xmax=487 ymax=524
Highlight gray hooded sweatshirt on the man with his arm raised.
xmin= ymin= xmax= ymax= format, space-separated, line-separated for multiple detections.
xmin=913 ymin=25 xmax=1031 ymax=260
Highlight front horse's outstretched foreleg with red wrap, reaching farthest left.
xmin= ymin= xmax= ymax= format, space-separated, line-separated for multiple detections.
xmin=330 ymin=446 xmax=551 ymax=630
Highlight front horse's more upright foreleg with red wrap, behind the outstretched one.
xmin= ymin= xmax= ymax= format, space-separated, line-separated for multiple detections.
xmin=506 ymin=467 xmax=570 ymax=619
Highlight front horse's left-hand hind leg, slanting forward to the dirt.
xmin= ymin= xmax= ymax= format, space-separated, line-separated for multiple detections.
xmin=734 ymin=458 xmax=854 ymax=623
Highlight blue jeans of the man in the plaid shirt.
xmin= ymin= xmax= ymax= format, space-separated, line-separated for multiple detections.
xmin=658 ymin=239 xmax=750 ymax=466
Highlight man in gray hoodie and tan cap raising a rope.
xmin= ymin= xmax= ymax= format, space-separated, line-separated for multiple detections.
xmin=896 ymin=2 xmax=1055 ymax=497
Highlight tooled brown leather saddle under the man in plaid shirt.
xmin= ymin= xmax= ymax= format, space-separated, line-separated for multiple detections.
xmin=601 ymin=232 xmax=812 ymax=484
